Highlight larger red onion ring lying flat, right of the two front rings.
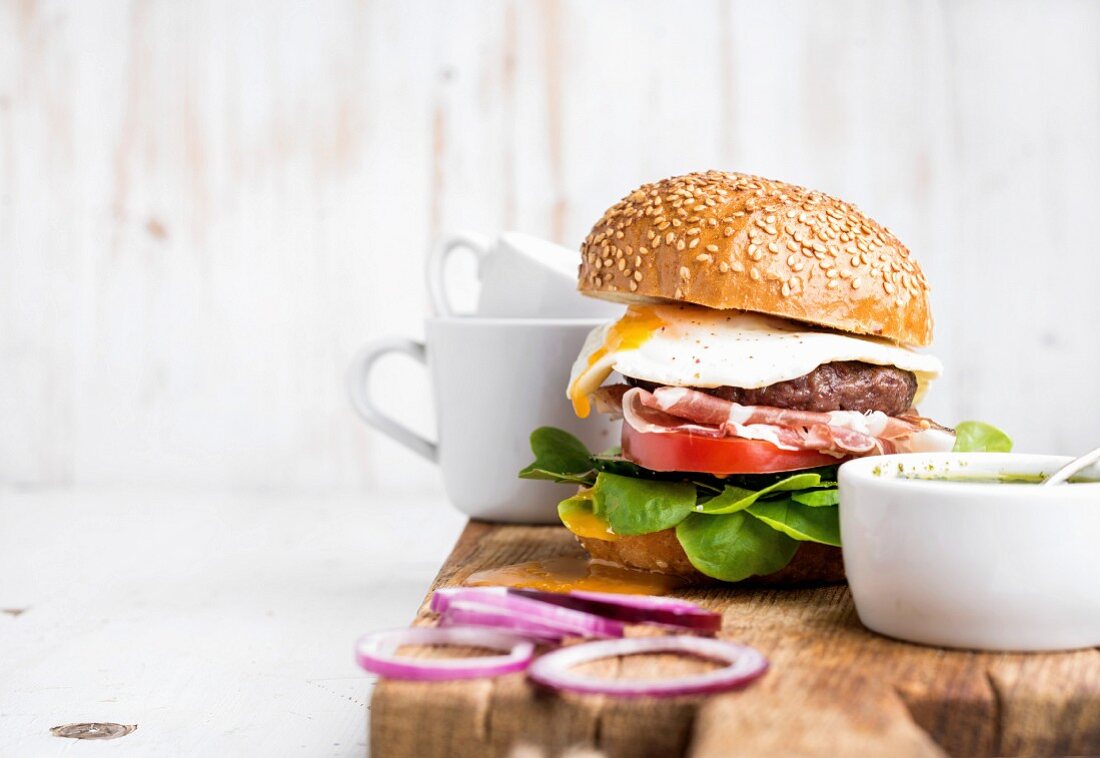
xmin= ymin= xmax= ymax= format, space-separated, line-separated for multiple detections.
xmin=527 ymin=635 xmax=768 ymax=697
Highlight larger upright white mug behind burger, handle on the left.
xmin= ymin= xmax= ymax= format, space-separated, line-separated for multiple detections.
xmin=348 ymin=317 xmax=618 ymax=524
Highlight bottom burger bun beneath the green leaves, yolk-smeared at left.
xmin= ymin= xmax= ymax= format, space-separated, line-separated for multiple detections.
xmin=574 ymin=529 xmax=845 ymax=586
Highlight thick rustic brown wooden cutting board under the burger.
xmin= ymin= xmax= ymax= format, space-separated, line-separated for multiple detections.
xmin=370 ymin=521 xmax=1100 ymax=758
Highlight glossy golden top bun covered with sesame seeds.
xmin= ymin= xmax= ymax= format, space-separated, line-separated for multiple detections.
xmin=578 ymin=172 xmax=932 ymax=345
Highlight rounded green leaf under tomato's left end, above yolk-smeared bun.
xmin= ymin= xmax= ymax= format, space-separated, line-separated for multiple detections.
xmin=591 ymin=471 xmax=695 ymax=535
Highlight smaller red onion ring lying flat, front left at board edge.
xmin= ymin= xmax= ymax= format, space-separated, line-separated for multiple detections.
xmin=355 ymin=626 xmax=535 ymax=682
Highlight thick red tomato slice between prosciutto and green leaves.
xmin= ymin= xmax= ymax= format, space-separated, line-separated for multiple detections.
xmin=623 ymin=424 xmax=840 ymax=476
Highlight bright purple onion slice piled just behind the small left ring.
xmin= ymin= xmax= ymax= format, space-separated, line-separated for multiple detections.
xmin=431 ymin=587 xmax=623 ymax=638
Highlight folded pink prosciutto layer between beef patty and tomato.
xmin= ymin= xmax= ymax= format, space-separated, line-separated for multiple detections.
xmin=594 ymin=384 xmax=955 ymax=458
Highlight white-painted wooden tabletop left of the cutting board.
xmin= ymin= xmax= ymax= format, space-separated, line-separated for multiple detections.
xmin=0 ymin=490 xmax=464 ymax=758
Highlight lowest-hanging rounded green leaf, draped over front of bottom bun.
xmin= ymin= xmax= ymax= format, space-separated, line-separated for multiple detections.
xmin=677 ymin=512 xmax=799 ymax=582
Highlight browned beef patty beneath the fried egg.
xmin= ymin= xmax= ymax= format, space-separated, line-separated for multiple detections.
xmin=626 ymin=361 xmax=916 ymax=416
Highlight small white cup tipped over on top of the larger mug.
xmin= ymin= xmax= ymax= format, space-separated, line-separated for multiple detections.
xmin=427 ymin=227 xmax=622 ymax=319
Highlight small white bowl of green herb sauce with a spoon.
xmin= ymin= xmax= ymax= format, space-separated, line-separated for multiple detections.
xmin=839 ymin=453 xmax=1100 ymax=650
